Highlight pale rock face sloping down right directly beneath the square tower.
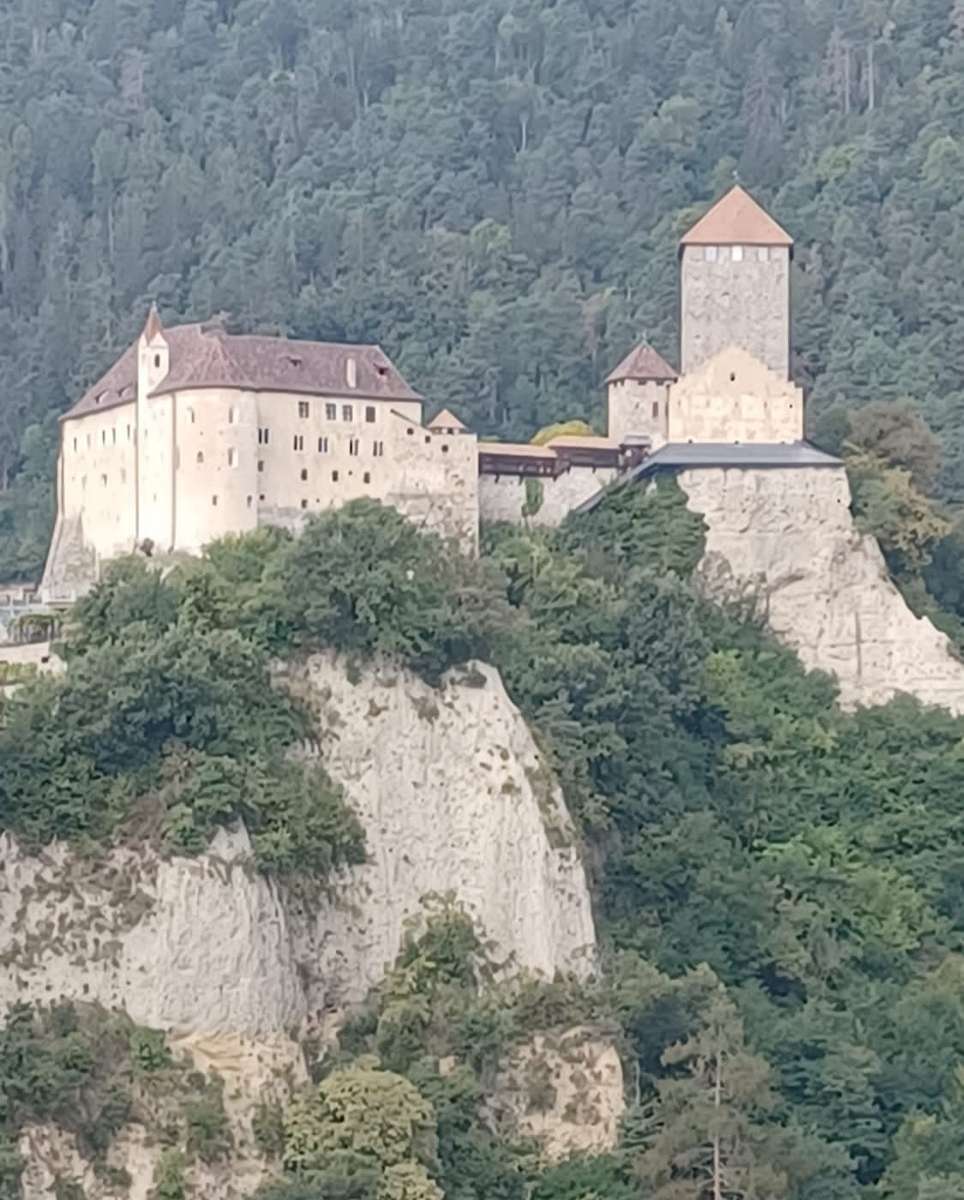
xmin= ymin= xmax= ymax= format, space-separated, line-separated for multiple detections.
xmin=679 ymin=467 xmax=964 ymax=713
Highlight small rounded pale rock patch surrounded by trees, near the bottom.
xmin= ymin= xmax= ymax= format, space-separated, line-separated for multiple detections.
xmin=489 ymin=1026 xmax=625 ymax=1162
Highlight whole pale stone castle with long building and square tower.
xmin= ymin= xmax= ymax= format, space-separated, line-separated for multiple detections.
xmin=41 ymin=187 xmax=839 ymax=604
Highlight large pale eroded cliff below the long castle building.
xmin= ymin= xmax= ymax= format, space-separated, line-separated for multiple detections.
xmin=0 ymin=655 xmax=595 ymax=1200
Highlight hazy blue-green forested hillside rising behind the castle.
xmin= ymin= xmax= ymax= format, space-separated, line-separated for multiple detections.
xmin=0 ymin=0 xmax=964 ymax=577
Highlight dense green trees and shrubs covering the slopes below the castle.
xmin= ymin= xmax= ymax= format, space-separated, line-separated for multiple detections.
xmin=9 ymin=494 xmax=964 ymax=1200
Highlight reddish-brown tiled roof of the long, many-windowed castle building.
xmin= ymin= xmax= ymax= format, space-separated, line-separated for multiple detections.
xmin=66 ymin=325 xmax=421 ymax=418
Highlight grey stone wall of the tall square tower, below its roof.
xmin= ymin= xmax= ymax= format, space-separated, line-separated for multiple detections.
xmin=679 ymin=246 xmax=790 ymax=379
